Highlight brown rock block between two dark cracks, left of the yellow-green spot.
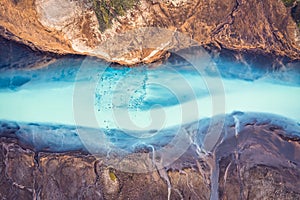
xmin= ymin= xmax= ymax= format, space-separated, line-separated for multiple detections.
xmin=35 ymin=154 xmax=102 ymax=199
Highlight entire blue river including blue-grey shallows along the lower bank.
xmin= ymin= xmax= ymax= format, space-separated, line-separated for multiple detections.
xmin=0 ymin=38 xmax=300 ymax=199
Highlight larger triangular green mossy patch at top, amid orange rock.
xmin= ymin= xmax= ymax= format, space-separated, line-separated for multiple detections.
xmin=90 ymin=0 xmax=139 ymax=32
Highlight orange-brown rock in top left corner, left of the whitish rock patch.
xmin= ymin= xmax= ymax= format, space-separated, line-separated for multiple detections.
xmin=0 ymin=0 xmax=75 ymax=54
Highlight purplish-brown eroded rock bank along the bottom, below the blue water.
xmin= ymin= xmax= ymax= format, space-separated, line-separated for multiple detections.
xmin=0 ymin=116 xmax=300 ymax=199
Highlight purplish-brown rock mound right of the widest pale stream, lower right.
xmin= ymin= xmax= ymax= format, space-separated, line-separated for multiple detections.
xmin=217 ymin=124 xmax=300 ymax=199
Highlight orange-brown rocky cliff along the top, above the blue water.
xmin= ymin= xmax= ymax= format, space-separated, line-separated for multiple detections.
xmin=0 ymin=0 xmax=300 ymax=65
